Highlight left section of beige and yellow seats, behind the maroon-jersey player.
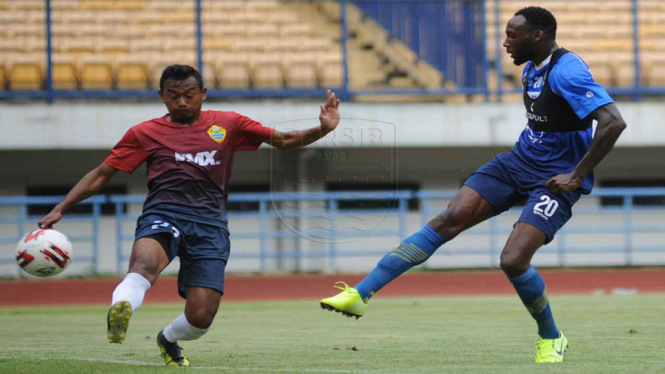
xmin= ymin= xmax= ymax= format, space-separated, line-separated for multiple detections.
xmin=0 ymin=0 xmax=443 ymax=89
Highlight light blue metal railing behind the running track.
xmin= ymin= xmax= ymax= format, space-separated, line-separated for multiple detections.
xmin=0 ymin=188 xmax=665 ymax=273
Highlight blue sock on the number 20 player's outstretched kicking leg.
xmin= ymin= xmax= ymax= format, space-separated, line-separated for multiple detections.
xmin=355 ymin=226 xmax=445 ymax=301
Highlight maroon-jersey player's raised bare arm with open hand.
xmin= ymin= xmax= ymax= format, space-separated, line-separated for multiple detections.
xmin=270 ymin=90 xmax=339 ymax=149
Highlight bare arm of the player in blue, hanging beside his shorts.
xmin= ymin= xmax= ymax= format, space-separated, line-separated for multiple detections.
xmin=545 ymin=104 xmax=626 ymax=193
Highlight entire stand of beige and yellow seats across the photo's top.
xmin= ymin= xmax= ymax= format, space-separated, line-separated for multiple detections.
xmin=0 ymin=0 xmax=665 ymax=90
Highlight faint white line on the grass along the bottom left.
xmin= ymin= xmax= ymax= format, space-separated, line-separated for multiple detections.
xmin=0 ymin=356 xmax=416 ymax=374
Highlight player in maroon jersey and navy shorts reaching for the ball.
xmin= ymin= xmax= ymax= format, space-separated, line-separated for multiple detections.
xmin=39 ymin=65 xmax=339 ymax=366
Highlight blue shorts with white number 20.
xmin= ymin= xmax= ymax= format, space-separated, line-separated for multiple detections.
xmin=464 ymin=153 xmax=582 ymax=244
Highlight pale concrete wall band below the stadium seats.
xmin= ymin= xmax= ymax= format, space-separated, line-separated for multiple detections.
xmin=0 ymin=100 xmax=665 ymax=150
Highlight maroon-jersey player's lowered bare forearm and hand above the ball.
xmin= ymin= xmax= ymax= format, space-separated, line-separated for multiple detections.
xmin=38 ymin=162 xmax=118 ymax=229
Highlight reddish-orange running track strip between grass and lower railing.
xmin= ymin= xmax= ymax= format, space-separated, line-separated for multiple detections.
xmin=0 ymin=268 xmax=665 ymax=306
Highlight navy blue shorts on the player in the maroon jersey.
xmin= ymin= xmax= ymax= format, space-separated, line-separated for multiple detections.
xmin=135 ymin=211 xmax=231 ymax=299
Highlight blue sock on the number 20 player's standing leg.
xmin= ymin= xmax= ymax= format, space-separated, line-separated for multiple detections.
xmin=508 ymin=266 xmax=559 ymax=339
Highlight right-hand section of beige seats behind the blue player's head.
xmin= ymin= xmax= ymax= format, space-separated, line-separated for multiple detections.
xmin=486 ymin=1 xmax=665 ymax=87
